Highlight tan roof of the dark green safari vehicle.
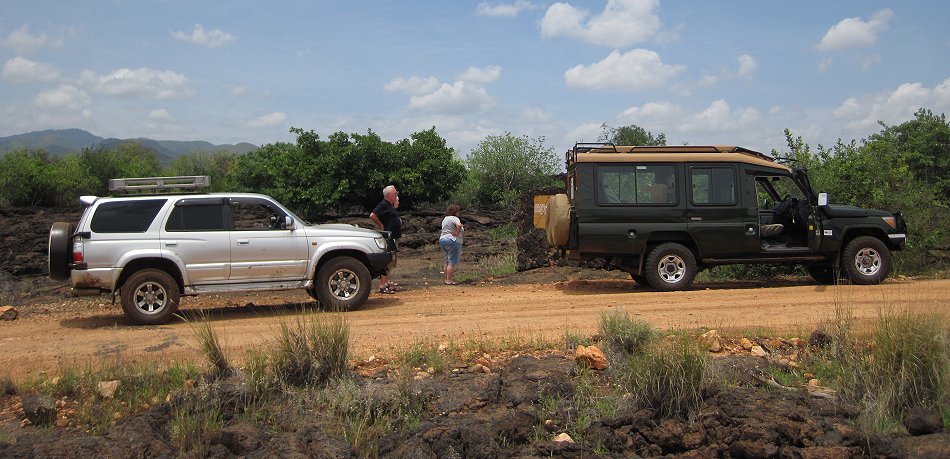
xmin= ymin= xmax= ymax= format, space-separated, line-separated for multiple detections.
xmin=575 ymin=145 xmax=790 ymax=171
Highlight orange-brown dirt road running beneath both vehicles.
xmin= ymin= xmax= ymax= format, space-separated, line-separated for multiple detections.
xmin=0 ymin=279 xmax=950 ymax=378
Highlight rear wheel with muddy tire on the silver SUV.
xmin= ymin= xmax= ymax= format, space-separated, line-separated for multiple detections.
xmin=119 ymin=269 xmax=181 ymax=325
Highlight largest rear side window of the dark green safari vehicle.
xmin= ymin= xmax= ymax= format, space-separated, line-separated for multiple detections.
xmin=597 ymin=164 xmax=677 ymax=205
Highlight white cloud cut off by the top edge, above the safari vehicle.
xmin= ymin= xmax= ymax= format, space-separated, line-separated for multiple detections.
xmin=541 ymin=0 xmax=660 ymax=48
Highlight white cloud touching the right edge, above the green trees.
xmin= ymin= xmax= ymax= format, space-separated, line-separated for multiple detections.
xmin=832 ymin=78 xmax=950 ymax=131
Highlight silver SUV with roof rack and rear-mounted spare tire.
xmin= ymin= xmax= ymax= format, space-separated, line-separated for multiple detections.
xmin=49 ymin=176 xmax=396 ymax=324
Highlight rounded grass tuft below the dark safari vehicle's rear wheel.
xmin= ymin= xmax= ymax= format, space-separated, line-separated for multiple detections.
xmin=621 ymin=338 xmax=715 ymax=419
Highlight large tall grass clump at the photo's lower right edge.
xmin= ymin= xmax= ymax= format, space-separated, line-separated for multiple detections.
xmin=838 ymin=310 xmax=950 ymax=432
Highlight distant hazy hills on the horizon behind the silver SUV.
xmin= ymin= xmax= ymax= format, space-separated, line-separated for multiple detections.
xmin=0 ymin=129 xmax=257 ymax=162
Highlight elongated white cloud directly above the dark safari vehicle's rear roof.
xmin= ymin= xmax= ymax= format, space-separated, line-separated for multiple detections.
xmin=564 ymin=49 xmax=686 ymax=90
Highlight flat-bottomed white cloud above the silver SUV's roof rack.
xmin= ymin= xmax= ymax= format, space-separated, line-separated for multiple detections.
xmin=81 ymin=67 xmax=192 ymax=99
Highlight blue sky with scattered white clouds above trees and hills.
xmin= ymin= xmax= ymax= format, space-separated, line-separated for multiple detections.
xmin=0 ymin=0 xmax=950 ymax=157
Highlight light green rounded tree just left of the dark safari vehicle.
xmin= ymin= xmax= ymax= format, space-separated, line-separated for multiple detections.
xmin=468 ymin=132 xmax=561 ymax=207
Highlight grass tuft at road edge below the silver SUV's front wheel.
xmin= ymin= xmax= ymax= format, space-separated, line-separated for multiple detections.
xmin=274 ymin=314 xmax=350 ymax=387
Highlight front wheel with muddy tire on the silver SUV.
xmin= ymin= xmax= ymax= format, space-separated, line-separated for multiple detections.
xmin=314 ymin=257 xmax=372 ymax=311
